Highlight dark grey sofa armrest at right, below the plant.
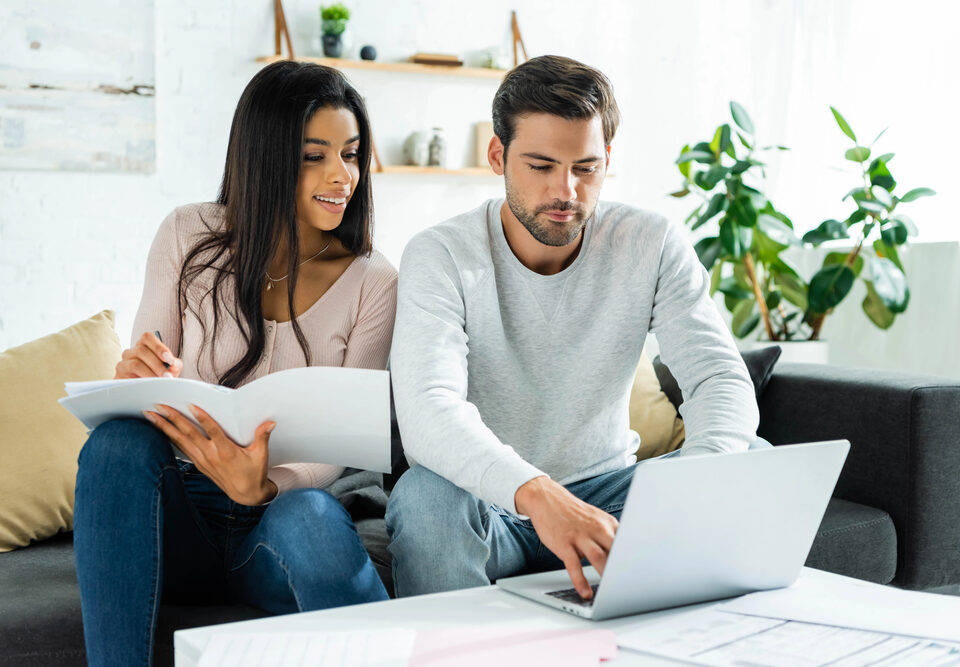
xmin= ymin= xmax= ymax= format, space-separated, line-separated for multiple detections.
xmin=758 ymin=364 xmax=960 ymax=589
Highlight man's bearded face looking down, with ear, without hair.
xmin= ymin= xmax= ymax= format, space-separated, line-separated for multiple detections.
xmin=490 ymin=113 xmax=609 ymax=246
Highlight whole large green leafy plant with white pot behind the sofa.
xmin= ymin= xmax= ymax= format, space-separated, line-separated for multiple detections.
xmin=672 ymin=102 xmax=935 ymax=362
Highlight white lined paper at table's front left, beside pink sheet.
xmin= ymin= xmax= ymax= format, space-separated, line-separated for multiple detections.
xmin=198 ymin=629 xmax=416 ymax=667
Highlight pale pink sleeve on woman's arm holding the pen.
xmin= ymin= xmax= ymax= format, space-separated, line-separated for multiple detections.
xmin=131 ymin=210 xmax=183 ymax=357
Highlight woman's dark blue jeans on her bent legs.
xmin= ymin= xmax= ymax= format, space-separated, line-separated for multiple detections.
xmin=74 ymin=419 xmax=387 ymax=665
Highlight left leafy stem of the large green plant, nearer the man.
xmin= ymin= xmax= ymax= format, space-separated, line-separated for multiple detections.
xmin=672 ymin=102 xmax=807 ymax=350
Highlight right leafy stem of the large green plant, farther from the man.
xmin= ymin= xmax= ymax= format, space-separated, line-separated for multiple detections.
xmin=803 ymin=107 xmax=936 ymax=340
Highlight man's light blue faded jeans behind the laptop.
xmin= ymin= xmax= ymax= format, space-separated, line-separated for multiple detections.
xmin=387 ymin=439 xmax=771 ymax=597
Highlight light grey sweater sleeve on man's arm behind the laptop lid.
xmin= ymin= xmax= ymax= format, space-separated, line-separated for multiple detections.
xmin=650 ymin=225 xmax=760 ymax=455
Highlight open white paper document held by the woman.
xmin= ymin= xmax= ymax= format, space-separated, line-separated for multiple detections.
xmin=60 ymin=367 xmax=390 ymax=472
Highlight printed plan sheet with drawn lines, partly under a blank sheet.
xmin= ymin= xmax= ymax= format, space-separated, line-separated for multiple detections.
xmin=617 ymin=607 xmax=960 ymax=667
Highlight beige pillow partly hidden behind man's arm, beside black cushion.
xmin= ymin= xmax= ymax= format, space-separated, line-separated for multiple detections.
xmin=630 ymin=352 xmax=685 ymax=461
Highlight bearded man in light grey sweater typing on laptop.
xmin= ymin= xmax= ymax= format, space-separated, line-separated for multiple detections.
xmin=387 ymin=56 xmax=758 ymax=598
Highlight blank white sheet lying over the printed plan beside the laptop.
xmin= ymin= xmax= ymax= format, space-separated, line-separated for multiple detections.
xmin=718 ymin=577 xmax=960 ymax=642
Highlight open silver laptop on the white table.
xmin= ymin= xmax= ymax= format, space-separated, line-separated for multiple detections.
xmin=496 ymin=440 xmax=850 ymax=621
